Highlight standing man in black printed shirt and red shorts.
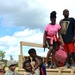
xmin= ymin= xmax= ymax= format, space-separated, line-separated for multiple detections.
xmin=60 ymin=9 xmax=75 ymax=67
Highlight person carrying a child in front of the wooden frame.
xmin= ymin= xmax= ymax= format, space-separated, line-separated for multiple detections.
xmin=23 ymin=48 xmax=46 ymax=75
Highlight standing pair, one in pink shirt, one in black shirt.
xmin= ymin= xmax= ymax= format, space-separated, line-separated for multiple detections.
xmin=43 ymin=9 xmax=75 ymax=68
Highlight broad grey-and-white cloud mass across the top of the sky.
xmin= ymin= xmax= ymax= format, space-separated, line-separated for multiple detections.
xmin=0 ymin=0 xmax=75 ymax=30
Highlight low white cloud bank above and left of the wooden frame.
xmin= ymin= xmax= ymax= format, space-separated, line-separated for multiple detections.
xmin=0 ymin=29 xmax=43 ymax=59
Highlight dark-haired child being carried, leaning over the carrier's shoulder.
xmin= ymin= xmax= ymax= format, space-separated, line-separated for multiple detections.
xmin=28 ymin=48 xmax=46 ymax=75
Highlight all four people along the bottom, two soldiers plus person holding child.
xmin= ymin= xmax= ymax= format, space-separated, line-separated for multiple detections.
xmin=0 ymin=48 xmax=46 ymax=75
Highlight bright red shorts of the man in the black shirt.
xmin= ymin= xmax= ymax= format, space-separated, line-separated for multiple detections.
xmin=64 ymin=42 xmax=75 ymax=54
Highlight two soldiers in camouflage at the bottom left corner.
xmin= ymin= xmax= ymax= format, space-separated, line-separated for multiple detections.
xmin=0 ymin=60 xmax=19 ymax=75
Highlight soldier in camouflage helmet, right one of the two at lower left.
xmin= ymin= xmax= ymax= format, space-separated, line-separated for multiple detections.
xmin=5 ymin=60 xmax=19 ymax=75
